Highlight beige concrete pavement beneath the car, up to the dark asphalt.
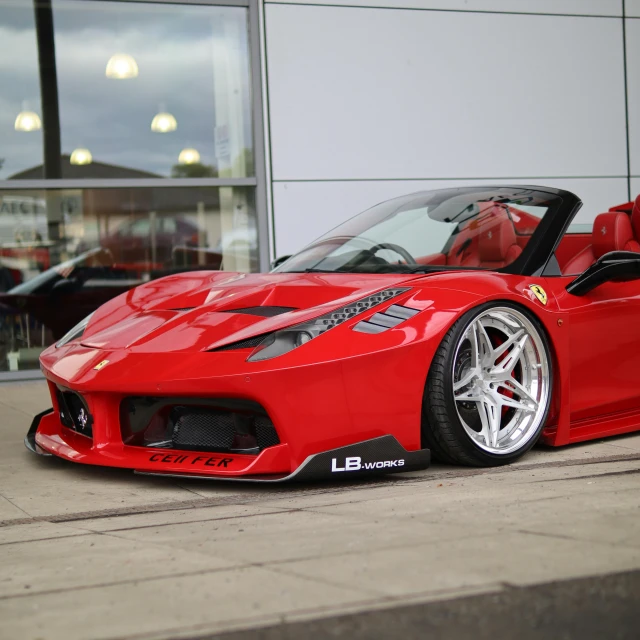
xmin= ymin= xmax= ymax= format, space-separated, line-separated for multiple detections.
xmin=0 ymin=382 xmax=640 ymax=640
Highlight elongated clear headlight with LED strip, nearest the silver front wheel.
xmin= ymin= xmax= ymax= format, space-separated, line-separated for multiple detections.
xmin=247 ymin=287 xmax=409 ymax=362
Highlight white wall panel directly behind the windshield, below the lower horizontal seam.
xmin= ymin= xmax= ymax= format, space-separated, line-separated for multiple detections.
xmin=273 ymin=178 xmax=628 ymax=256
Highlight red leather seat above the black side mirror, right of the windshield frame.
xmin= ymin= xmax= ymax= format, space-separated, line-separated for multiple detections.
xmin=563 ymin=212 xmax=640 ymax=275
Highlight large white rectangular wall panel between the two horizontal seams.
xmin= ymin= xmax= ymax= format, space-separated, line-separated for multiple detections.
xmin=266 ymin=5 xmax=626 ymax=180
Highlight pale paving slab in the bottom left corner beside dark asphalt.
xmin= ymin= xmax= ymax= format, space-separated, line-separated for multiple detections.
xmin=0 ymin=567 xmax=380 ymax=640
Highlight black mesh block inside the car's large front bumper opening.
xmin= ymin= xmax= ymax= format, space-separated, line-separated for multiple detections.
xmin=173 ymin=407 xmax=236 ymax=450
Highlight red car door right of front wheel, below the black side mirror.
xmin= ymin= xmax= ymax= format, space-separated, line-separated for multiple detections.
xmin=558 ymin=280 xmax=640 ymax=423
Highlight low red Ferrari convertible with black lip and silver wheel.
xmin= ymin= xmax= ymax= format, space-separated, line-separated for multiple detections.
xmin=26 ymin=186 xmax=640 ymax=481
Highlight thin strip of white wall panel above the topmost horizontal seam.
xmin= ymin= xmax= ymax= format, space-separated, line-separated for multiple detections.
xmin=266 ymin=0 xmax=620 ymax=16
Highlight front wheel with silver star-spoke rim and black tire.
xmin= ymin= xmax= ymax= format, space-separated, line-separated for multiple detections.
xmin=422 ymin=302 xmax=553 ymax=467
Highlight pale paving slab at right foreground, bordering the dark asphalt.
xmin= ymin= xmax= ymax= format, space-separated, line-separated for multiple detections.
xmin=278 ymin=531 xmax=640 ymax=596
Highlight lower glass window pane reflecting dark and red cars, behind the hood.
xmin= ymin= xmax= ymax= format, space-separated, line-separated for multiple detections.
xmin=0 ymin=187 xmax=258 ymax=371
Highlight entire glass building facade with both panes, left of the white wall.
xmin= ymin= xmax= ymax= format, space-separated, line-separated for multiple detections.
xmin=0 ymin=0 xmax=268 ymax=372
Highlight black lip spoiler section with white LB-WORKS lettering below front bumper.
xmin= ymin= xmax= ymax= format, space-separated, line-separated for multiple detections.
xmin=135 ymin=435 xmax=431 ymax=483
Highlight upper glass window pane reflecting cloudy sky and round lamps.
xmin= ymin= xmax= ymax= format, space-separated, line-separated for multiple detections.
xmin=0 ymin=0 xmax=254 ymax=179
